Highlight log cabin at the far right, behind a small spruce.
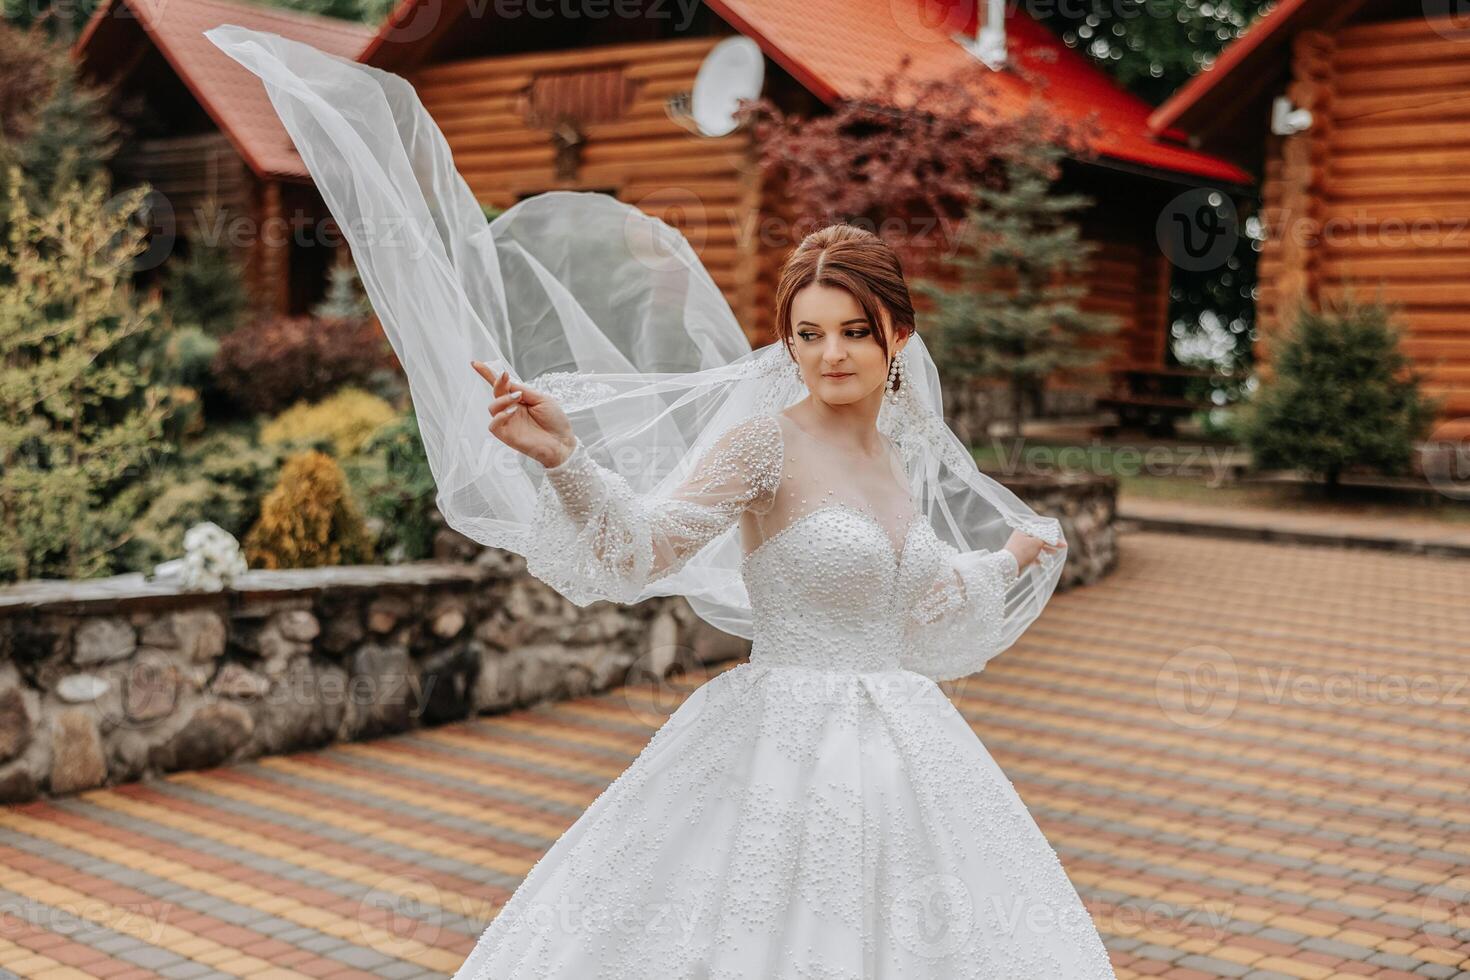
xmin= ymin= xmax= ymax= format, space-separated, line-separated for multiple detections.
xmin=1150 ymin=0 xmax=1470 ymax=442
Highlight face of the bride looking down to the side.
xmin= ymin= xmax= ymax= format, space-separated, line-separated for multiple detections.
xmin=791 ymin=282 xmax=908 ymax=404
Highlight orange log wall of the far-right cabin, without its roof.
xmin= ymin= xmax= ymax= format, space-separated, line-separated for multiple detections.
xmin=1257 ymin=16 xmax=1470 ymax=435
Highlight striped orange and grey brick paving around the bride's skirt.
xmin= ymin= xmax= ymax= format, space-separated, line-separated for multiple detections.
xmin=0 ymin=533 xmax=1470 ymax=980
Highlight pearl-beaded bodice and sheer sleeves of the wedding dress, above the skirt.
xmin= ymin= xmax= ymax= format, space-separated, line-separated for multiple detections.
xmin=526 ymin=414 xmax=1034 ymax=680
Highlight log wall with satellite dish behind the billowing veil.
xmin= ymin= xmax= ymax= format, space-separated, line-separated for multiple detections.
xmin=410 ymin=37 xmax=760 ymax=335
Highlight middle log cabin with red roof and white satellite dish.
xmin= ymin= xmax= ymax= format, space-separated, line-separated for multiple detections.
xmin=362 ymin=0 xmax=1250 ymax=410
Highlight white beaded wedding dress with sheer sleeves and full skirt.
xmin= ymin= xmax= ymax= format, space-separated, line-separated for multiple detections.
xmin=454 ymin=411 xmax=1114 ymax=980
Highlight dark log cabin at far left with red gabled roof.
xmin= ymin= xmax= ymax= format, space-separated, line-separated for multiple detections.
xmin=72 ymin=0 xmax=375 ymax=314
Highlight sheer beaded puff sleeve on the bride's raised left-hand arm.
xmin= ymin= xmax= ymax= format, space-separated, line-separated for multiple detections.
xmin=525 ymin=416 xmax=782 ymax=605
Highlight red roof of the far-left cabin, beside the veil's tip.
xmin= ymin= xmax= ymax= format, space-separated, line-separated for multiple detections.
xmin=72 ymin=0 xmax=376 ymax=181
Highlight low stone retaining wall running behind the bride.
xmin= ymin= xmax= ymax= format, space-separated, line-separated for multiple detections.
xmin=0 ymin=478 xmax=1116 ymax=802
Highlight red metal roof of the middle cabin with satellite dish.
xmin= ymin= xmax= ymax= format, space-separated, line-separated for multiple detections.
xmin=362 ymin=0 xmax=1254 ymax=187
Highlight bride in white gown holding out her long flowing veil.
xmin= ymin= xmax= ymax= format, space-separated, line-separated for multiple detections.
xmin=204 ymin=25 xmax=1114 ymax=980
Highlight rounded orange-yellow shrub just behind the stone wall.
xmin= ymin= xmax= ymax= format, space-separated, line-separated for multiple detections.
xmin=243 ymin=450 xmax=372 ymax=569
